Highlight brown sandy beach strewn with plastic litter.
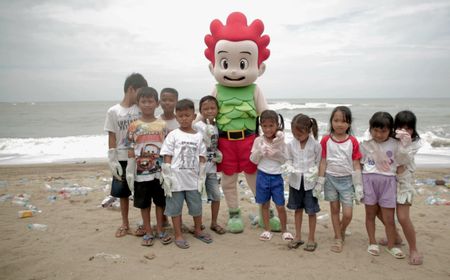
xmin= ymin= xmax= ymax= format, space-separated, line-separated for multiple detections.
xmin=0 ymin=163 xmax=450 ymax=279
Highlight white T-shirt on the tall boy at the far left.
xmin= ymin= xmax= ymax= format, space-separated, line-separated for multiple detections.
xmin=104 ymin=104 xmax=141 ymax=161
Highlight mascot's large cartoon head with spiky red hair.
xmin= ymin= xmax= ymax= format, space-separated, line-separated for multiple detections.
xmin=205 ymin=12 xmax=270 ymax=87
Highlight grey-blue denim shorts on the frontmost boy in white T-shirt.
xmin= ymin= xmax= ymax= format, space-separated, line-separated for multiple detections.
xmin=164 ymin=190 xmax=202 ymax=217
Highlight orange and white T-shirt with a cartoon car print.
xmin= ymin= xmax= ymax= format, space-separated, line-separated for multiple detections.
xmin=128 ymin=119 xmax=166 ymax=182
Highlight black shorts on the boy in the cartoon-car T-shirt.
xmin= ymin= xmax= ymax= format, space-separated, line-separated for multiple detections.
xmin=133 ymin=179 xmax=166 ymax=209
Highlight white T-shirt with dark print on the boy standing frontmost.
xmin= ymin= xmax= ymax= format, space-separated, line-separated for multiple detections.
xmin=160 ymin=128 xmax=206 ymax=192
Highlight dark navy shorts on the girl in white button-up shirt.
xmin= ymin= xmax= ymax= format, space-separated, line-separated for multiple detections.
xmin=286 ymin=177 xmax=320 ymax=215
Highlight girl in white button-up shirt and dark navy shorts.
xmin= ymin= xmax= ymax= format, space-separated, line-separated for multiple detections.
xmin=287 ymin=114 xmax=322 ymax=252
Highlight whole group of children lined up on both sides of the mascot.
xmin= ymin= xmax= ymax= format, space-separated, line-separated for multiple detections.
xmin=105 ymin=74 xmax=422 ymax=264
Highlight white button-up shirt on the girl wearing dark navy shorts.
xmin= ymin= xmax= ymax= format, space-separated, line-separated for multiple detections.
xmin=287 ymin=136 xmax=322 ymax=191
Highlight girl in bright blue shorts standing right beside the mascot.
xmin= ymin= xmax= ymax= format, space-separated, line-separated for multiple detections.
xmin=250 ymin=110 xmax=294 ymax=241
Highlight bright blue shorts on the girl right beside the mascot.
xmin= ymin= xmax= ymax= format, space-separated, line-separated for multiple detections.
xmin=255 ymin=169 xmax=286 ymax=206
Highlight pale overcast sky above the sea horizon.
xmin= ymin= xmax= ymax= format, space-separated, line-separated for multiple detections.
xmin=0 ymin=0 xmax=450 ymax=102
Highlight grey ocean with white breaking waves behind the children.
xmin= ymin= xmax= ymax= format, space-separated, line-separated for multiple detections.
xmin=0 ymin=98 xmax=450 ymax=168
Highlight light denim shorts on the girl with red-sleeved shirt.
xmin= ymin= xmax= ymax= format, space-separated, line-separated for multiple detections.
xmin=324 ymin=174 xmax=354 ymax=207
